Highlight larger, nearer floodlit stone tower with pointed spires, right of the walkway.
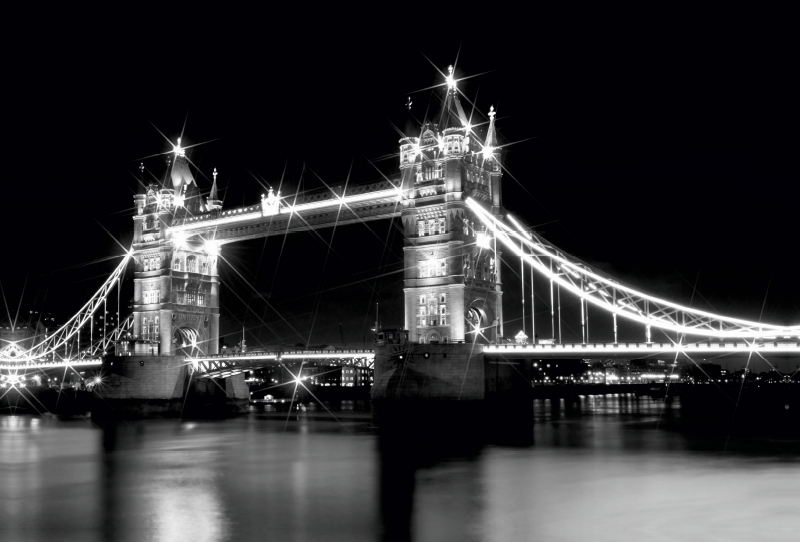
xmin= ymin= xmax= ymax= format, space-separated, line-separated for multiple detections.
xmin=400 ymin=66 xmax=503 ymax=343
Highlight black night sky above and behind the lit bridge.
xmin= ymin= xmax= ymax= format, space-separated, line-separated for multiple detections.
xmin=2 ymin=18 xmax=800 ymax=352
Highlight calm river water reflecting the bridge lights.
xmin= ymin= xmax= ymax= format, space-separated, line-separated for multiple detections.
xmin=0 ymin=395 xmax=800 ymax=542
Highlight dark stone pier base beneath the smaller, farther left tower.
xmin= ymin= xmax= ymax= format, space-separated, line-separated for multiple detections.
xmin=91 ymin=356 xmax=249 ymax=420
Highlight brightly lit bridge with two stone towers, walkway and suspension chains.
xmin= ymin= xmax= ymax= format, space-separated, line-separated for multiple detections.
xmin=0 ymin=65 xmax=800 ymax=420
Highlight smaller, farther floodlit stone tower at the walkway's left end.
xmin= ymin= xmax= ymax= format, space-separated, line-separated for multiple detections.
xmin=133 ymin=139 xmax=221 ymax=355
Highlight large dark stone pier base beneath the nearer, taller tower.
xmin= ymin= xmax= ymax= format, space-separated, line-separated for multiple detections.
xmin=372 ymin=344 xmax=533 ymax=437
